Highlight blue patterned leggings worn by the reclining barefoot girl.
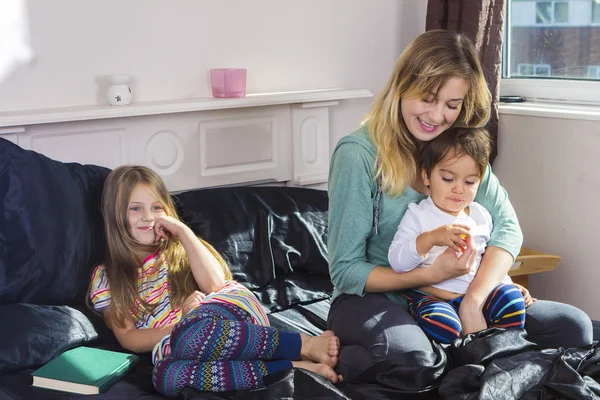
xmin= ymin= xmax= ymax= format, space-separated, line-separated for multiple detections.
xmin=152 ymin=303 xmax=302 ymax=396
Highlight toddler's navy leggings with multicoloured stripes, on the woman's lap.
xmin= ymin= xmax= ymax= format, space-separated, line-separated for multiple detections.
xmin=404 ymin=284 xmax=525 ymax=343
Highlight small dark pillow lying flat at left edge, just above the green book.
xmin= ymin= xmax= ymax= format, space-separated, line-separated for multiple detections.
xmin=0 ymin=304 xmax=98 ymax=374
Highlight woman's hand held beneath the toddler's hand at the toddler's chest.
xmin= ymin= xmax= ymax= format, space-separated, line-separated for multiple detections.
xmin=427 ymin=236 xmax=477 ymax=284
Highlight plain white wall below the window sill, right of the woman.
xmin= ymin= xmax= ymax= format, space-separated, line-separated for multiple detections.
xmin=494 ymin=114 xmax=600 ymax=320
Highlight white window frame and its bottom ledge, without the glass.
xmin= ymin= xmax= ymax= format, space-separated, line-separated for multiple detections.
xmin=500 ymin=0 xmax=600 ymax=105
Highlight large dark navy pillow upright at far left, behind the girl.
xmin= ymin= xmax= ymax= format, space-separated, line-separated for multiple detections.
xmin=0 ymin=138 xmax=110 ymax=305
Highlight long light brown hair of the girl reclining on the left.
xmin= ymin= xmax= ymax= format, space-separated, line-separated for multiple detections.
xmin=94 ymin=166 xmax=231 ymax=327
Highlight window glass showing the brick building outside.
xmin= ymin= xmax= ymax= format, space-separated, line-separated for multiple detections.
xmin=503 ymin=0 xmax=600 ymax=81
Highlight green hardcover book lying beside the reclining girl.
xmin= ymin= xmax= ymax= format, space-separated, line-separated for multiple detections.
xmin=31 ymin=346 xmax=138 ymax=394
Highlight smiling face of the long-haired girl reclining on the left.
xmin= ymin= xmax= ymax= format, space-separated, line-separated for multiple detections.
xmin=127 ymin=184 xmax=166 ymax=245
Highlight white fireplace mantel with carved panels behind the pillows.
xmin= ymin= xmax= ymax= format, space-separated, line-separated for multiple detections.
xmin=0 ymin=89 xmax=372 ymax=191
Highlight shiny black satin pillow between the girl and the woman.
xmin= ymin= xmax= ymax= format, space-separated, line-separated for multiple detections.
xmin=175 ymin=187 xmax=333 ymax=311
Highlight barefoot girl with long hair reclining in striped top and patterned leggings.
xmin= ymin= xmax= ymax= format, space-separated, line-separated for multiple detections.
xmin=90 ymin=166 xmax=341 ymax=396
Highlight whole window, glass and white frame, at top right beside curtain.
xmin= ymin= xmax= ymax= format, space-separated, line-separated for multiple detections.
xmin=500 ymin=0 xmax=600 ymax=103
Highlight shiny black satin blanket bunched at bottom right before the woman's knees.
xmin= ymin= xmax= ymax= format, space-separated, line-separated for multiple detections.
xmin=439 ymin=329 xmax=600 ymax=400
